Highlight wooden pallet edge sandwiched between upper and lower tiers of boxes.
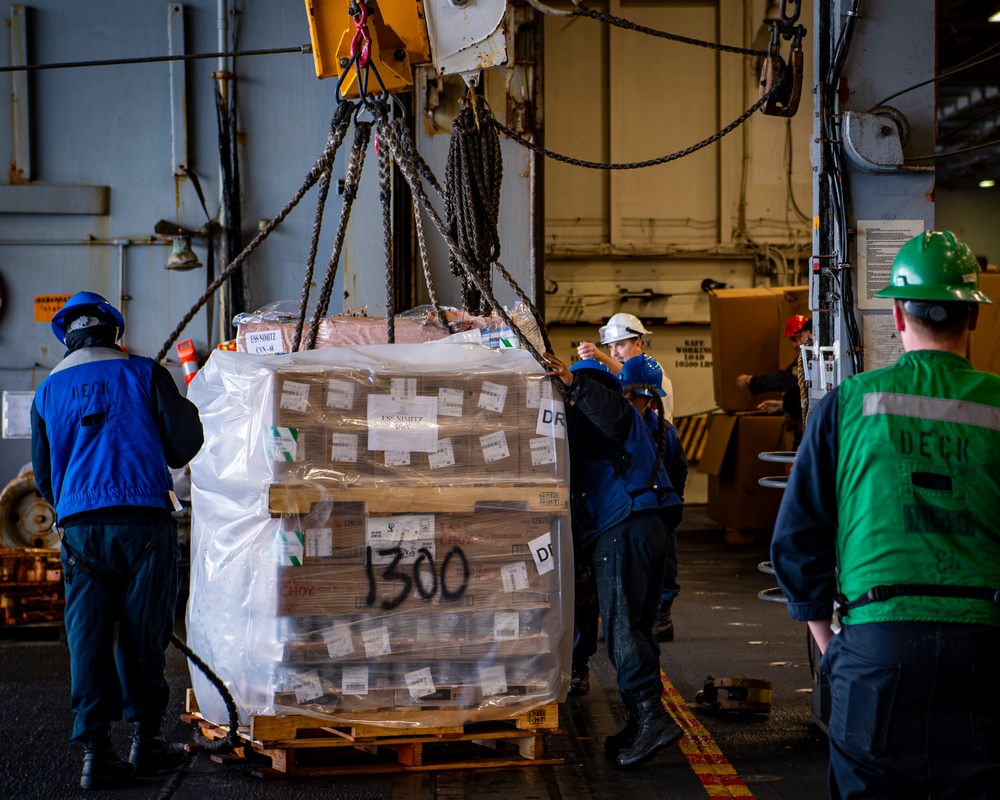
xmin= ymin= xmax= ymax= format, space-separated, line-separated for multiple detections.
xmin=268 ymin=481 xmax=569 ymax=516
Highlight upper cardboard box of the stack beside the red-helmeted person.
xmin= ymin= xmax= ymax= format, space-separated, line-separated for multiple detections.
xmin=708 ymin=286 xmax=810 ymax=412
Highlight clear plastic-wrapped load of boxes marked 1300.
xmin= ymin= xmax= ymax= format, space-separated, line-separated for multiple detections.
xmin=187 ymin=344 xmax=573 ymax=728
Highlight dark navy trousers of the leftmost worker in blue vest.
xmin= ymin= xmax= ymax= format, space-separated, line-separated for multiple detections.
xmin=62 ymin=516 xmax=180 ymax=742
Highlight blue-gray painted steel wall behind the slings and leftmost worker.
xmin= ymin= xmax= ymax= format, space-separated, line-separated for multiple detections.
xmin=0 ymin=0 xmax=524 ymax=487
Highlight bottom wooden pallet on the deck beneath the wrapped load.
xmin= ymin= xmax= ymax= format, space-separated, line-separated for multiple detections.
xmin=182 ymin=689 xmax=564 ymax=778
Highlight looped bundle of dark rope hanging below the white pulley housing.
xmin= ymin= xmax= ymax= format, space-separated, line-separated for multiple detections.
xmin=445 ymin=92 xmax=503 ymax=314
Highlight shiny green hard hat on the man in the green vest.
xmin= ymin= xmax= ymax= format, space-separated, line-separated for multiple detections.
xmin=875 ymin=231 xmax=993 ymax=303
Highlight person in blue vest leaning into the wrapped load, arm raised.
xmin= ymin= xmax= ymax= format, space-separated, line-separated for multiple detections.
xmin=543 ymin=353 xmax=684 ymax=767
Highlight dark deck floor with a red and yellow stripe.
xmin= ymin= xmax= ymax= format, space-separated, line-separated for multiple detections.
xmin=0 ymin=508 xmax=827 ymax=800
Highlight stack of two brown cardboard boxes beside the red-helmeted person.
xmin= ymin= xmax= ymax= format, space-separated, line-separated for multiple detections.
xmin=698 ymin=286 xmax=811 ymax=531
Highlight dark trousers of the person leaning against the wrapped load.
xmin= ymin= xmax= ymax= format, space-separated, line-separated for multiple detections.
xmin=593 ymin=511 xmax=666 ymax=698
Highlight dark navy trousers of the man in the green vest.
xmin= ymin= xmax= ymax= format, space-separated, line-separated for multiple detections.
xmin=820 ymin=622 xmax=1000 ymax=800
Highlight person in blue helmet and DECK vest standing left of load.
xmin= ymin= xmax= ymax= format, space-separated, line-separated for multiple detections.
xmin=31 ymin=292 xmax=203 ymax=789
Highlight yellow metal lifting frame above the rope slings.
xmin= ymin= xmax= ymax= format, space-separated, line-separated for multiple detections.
xmin=305 ymin=0 xmax=431 ymax=97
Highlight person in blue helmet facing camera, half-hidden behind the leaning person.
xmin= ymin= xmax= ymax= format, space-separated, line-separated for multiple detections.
xmin=618 ymin=354 xmax=688 ymax=642
